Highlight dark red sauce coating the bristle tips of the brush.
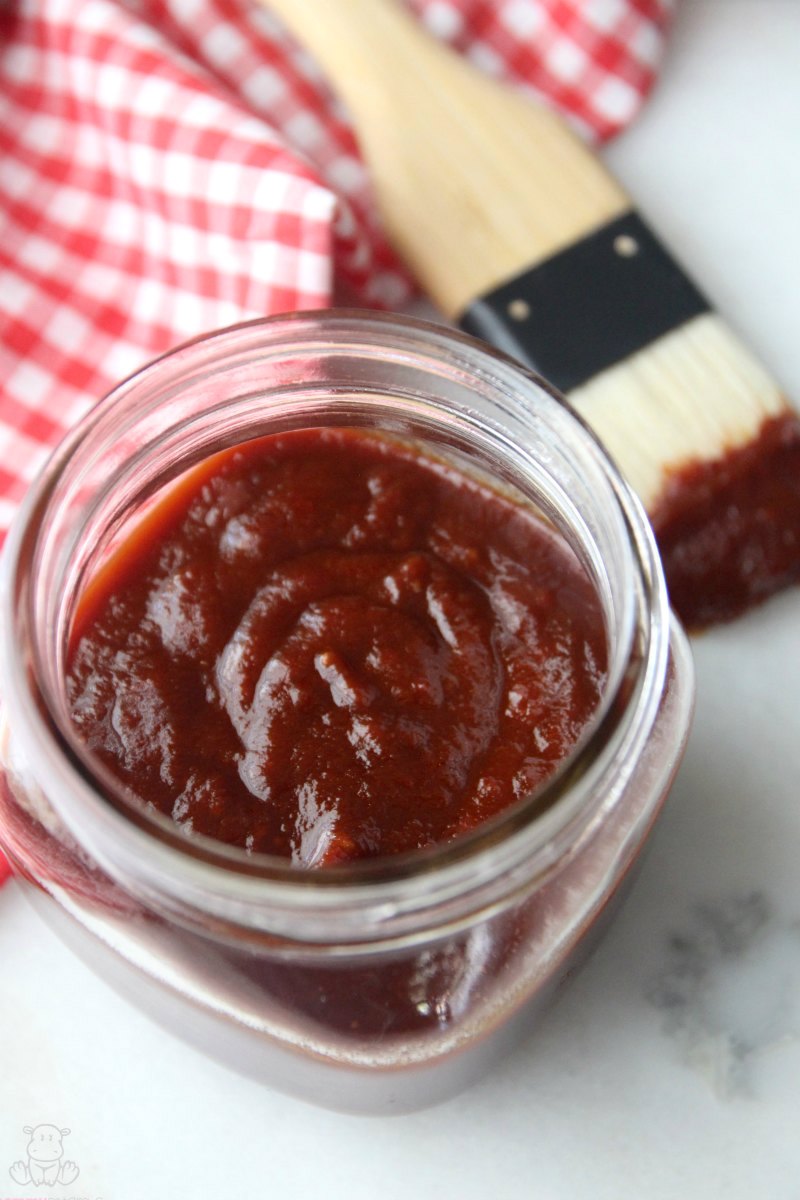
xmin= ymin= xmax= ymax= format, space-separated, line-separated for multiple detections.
xmin=651 ymin=413 xmax=800 ymax=629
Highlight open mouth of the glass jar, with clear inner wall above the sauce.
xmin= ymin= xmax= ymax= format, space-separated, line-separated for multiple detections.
xmin=0 ymin=310 xmax=669 ymax=926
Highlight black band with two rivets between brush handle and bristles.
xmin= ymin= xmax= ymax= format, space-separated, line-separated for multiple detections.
xmin=458 ymin=212 xmax=709 ymax=391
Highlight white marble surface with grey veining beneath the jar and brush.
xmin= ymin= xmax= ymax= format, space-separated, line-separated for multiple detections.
xmin=0 ymin=0 xmax=800 ymax=1200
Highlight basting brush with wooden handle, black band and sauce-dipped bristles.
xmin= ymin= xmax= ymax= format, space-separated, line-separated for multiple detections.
xmin=265 ymin=0 xmax=800 ymax=626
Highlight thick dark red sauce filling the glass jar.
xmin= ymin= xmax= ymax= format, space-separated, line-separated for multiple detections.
xmin=68 ymin=430 xmax=606 ymax=866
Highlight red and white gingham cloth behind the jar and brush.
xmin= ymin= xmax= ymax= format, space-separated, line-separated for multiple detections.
xmin=0 ymin=0 xmax=674 ymax=878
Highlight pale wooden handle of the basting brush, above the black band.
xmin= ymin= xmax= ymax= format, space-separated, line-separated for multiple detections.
xmin=263 ymin=0 xmax=631 ymax=317
